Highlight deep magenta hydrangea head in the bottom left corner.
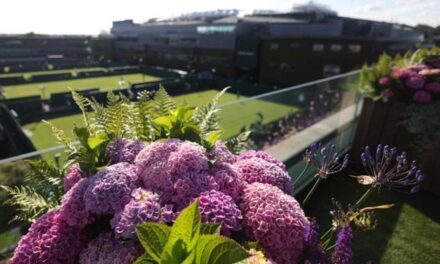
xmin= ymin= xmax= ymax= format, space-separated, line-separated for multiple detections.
xmin=9 ymin=211 xmax=82 ymax=264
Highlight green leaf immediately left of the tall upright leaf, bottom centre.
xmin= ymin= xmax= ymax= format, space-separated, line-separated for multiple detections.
xmin=136 ymin=223 xmax=171 ymax=262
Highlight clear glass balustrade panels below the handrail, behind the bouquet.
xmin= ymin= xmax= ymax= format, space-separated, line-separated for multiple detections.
xmin=0 ymin=71 xmax=362 ymax=259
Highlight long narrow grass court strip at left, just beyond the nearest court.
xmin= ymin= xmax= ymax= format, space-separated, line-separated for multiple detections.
xmin=5 ymin=73 xmax=160 ymax=98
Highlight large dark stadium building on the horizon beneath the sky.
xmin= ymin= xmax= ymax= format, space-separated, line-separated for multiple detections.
xmin=111 ymin=4 xmax=423 ymax=85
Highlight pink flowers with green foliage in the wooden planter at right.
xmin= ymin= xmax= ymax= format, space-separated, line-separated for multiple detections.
xmin=360 ymin=48 xmax=440 ymax=104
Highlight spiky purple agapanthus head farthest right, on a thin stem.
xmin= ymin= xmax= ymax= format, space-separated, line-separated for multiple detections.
xmin=356 ymin=145 xmax=424 ymax=189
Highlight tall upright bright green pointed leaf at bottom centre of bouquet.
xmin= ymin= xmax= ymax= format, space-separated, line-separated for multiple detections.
xmin=161 ymin=200 xmax=201 ymax=263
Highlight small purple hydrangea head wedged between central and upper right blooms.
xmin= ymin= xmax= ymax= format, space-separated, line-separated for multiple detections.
xmin=209 ymin=163 xmax=246 ymax=201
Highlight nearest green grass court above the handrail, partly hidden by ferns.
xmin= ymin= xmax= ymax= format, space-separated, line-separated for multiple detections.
xmin=24 ymin=87 xmax=298 ymax=149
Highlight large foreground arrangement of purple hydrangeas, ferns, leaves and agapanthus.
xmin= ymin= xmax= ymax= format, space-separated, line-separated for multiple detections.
xmin=2 ymin=89 xmax=423 ymax=264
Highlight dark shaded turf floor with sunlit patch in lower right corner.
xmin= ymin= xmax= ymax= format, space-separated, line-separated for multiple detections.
xmin=298 ymin=172 xmax=440 ymax=264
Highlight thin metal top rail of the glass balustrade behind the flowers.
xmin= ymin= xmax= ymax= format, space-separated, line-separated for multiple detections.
xmin=0 ymin=70 xmax=361 ymax=165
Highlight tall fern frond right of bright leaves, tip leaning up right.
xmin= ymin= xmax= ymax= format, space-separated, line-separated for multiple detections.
xmin=193 ymin=87 xmax=230 ymax=135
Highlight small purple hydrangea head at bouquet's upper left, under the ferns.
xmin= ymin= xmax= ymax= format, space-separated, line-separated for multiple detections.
xmin=107 ymin=138 xmax=146 ymax=163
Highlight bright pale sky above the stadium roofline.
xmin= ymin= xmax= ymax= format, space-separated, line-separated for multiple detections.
xmin=0 ymin=0 xmax=440 ymax=35
